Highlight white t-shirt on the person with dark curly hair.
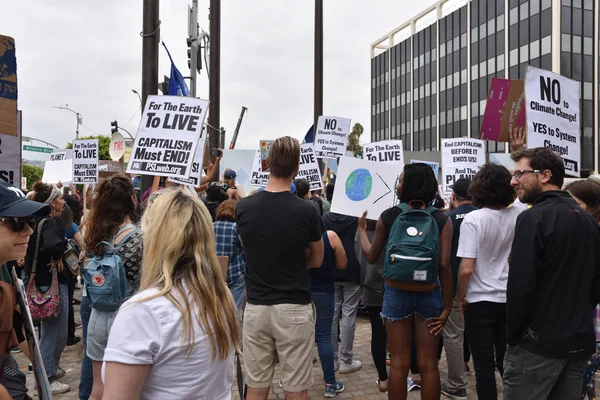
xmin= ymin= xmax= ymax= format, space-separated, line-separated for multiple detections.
xmin=456 ymin=201 xmax=527 ymax=303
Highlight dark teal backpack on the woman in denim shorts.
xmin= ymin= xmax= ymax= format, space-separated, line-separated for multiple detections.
xmin=383 ymin=202 xmax=440 ymax=284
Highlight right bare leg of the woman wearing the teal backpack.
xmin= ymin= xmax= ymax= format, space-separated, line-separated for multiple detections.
xmin=415 ymin=316 xmax=441 ymax=400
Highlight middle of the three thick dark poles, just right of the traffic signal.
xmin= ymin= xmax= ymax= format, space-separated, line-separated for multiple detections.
xmin=208 ymin=0 xmax=221 ymax=161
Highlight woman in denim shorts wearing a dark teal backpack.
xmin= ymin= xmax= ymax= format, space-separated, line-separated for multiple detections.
xmin=358 ymin=163 xmax=452 ymax=400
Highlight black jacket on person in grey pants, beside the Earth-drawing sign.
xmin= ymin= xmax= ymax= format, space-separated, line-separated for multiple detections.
xmin=322 ymin=212 xmax=360 ymax=285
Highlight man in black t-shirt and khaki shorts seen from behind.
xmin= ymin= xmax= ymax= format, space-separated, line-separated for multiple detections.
xmin=236 ymin=136 xmax=323 ymax=400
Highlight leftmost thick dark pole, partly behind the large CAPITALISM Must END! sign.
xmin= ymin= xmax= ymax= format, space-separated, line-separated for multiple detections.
xmin=142 ymin=0 xmax=160 ymax=193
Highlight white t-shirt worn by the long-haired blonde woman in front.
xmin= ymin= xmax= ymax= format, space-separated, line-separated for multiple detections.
xmin=104 ymin=289 xmax=235 ymax=400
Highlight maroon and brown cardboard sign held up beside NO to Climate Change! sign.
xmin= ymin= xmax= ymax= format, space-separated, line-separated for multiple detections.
xmin=479 ymin=78 xmax=525 ymax=142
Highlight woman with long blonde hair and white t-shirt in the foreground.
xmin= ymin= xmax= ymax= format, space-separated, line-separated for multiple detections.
xmin=103 ymin=189 xmax=239 ymax=400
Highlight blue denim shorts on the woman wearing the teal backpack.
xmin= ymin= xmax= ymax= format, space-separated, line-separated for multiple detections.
xmin=381 ymin=282 xmax=443 ymax=321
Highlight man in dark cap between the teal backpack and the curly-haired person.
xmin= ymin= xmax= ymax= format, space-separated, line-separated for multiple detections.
xmin=442 ymin=178 xmax=477 ymax=400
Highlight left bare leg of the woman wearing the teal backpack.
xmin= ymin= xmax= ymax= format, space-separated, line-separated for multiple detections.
xmin=385 ymin=317 xmax=414 ymax=400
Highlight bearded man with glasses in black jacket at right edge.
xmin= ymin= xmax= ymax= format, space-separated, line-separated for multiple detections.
xmin=503 ymin=148 xmax=600 ymax=400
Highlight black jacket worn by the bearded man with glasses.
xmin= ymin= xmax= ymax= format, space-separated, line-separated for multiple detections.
xmin=506 ymin=191 xmax=600 ymax=358
